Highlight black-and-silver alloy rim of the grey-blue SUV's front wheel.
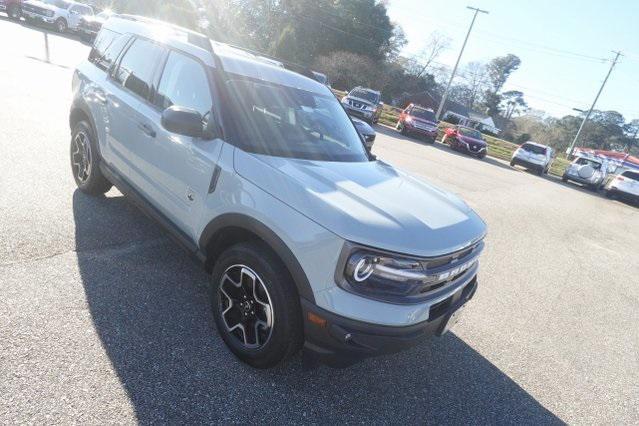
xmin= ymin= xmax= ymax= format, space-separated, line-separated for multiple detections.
xmin=218 ymin=265 xmax=274 ymax=349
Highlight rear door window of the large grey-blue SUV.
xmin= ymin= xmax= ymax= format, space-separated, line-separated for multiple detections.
xmin=114 ymin=39 xmax=164 ymax=99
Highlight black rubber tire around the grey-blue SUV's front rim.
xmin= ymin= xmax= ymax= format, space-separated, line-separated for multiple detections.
xmin=209 ymin=242 xmax=304 ymax=368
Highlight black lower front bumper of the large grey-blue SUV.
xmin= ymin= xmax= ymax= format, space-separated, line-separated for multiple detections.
xmin=302 ymin=276 xmax=477 ymax=367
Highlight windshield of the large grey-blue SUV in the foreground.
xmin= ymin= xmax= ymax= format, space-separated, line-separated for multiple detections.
xmin=228 ymin=80 xmax=368 ymax=162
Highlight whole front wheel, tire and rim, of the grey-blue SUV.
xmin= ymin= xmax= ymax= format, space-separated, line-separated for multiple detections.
xmin=210 ymin=242 xmax=303 ymax=368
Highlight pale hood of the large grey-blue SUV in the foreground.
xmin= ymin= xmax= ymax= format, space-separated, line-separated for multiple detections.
xmin=235 ymin=149 xmax=486 ymax=257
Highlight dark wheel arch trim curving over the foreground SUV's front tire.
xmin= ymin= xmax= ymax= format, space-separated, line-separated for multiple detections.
xmin=198 ymin=213 xmax=315 ymax=303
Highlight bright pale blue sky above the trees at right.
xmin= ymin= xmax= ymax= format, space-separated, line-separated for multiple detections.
xmin=388 ymin=0 xmax=639 ymax=121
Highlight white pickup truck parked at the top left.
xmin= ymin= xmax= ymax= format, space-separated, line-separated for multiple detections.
xmin=22 ymin=0 xmax=93 ymax=33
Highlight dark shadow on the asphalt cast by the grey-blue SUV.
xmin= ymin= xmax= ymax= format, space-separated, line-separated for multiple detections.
xmin=73 ymin=191 xmax=560 ymax=424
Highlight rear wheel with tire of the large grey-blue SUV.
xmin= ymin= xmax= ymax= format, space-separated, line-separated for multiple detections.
xmin=70 ymin=121 xmax=113 ymax=195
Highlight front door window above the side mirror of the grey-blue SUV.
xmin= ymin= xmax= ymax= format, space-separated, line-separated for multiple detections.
xmin=154 ymin=52 xmax=213 ymax=116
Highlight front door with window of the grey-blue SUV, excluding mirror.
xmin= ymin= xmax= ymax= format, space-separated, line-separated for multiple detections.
xmin=132 ymin=50 xmax=223 ymax=240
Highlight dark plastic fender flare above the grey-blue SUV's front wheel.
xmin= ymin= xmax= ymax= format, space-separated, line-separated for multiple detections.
xmin=198 ymin=213 xmax=315 ymax=303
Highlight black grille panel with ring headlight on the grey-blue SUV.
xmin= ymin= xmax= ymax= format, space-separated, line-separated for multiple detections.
xmin=336 ymin=243 xmax=483 ymax=303
